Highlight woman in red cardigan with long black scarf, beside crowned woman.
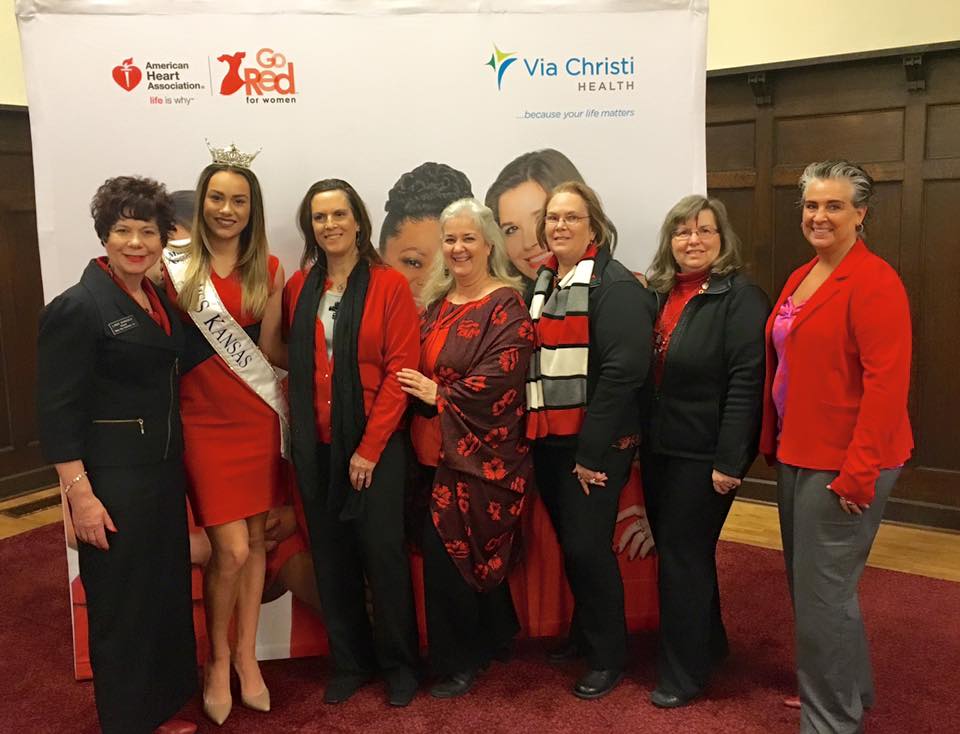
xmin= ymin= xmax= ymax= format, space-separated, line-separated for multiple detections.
xmin=284 ymin=179 xmax=420 ymax=706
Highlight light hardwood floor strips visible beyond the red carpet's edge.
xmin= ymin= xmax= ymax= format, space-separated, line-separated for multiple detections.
xmin=0 ymin=487 xmax=960 ymax=582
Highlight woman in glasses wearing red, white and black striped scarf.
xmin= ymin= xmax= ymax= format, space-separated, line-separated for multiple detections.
xmin=527 ymin=182 xmax=655 ymax=698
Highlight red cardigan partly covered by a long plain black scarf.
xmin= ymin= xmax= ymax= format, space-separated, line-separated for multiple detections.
xmin=283 ymin=265 xmax=420 ymax=463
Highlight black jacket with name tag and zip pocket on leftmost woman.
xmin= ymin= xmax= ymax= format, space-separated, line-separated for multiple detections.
xmin=37 ymin=262 xmax=183 ymax=467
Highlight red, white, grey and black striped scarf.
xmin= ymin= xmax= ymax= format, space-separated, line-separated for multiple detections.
xmin=527 ymin=244 xmax=597 ymax=440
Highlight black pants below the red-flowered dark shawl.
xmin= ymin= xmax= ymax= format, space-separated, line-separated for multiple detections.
xmin=423 ymin=474 xmax=520 ymax=676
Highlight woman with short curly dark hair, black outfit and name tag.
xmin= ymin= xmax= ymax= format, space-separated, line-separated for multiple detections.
xmin=38 ymin=176 xmax=197 ymax=734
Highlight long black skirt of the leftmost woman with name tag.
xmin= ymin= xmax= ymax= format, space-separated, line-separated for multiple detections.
xmin=81 ymin=459 xmax=197 ymax=734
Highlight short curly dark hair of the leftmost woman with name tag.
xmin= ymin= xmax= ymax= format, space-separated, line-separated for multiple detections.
xmin=90 ymin=176 xmax=174 ymax=244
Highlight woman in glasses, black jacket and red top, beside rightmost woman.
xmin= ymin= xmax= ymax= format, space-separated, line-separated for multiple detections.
xmin=640 ymin=196 xmax=770 ymax=708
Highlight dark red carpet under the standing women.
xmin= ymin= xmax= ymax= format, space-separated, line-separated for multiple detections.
xmin=0 ymin=526 xmax=960 ymax=734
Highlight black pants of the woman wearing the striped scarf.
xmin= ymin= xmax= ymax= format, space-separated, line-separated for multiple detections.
xmin=533 ymin=443 xmax=633 ymax=670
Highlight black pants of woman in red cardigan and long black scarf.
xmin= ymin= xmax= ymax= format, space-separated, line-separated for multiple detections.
xmin=304 ymin=434 xmax=419 ymax=680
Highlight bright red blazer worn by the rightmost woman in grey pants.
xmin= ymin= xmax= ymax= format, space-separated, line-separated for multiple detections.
xmin=760 ymin=240 xmax=913 ymax=504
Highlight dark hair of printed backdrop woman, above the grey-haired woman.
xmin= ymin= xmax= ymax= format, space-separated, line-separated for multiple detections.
xmin=380 ymin=161 xmax=473 ymax=252
